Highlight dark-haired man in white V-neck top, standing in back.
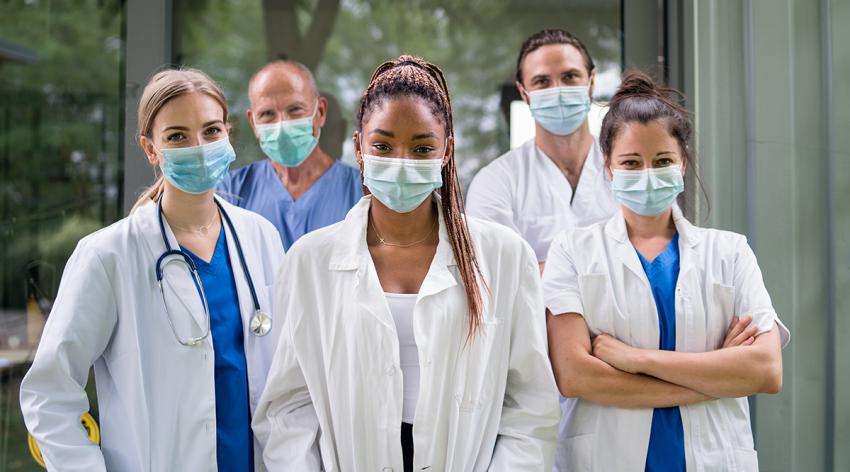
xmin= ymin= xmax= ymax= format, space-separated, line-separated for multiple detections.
xmin=467 ymin=30 xmax=617 ymax=270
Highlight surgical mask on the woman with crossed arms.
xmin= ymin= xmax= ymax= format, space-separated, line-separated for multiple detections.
xmin=612 ymin=166 xmax=685 ymax=216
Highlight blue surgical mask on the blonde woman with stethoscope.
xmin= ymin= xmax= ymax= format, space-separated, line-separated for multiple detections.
xmin=159 ymin=138 xmax=236 ymax=194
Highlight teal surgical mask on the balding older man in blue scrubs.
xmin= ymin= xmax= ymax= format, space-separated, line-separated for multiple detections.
xmin=255 ymin=103 xmax=321 ymax=167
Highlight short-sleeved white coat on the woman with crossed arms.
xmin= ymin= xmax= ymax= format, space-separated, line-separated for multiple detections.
xmin=543 ymin=206 xmax=789 ymax=472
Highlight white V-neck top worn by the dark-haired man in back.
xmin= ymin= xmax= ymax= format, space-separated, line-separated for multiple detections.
xmin=466 ymin=137 xmax=619 ymax=262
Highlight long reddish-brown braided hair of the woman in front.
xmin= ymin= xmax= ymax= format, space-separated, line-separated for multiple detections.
xmin=357 ymin=55 xmax=487 ymax=341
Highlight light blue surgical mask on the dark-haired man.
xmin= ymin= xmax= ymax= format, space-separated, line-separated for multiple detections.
xmin=526 ymin=84 xmax=590 ymax=136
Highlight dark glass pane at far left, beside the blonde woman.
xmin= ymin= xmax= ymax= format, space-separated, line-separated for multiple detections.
xmin=0 ymin=0 xmax=124 ymax=470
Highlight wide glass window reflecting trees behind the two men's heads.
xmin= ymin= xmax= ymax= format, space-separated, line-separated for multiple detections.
xmin=174 ymin=0 xmax=622 ymax=185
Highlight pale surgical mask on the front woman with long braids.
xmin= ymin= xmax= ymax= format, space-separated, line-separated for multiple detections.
xmin=363 ymin=154 xmax=443 ymax=213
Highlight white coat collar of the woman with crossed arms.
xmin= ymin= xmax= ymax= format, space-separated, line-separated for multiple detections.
xmin=605 ymin=204 xmax=702 ymax=284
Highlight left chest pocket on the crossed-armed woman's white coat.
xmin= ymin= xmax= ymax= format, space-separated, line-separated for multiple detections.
xmin=579 ymin=273 xmax=629 ymax=342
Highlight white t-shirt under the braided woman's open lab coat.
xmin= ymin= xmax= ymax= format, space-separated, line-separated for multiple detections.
xmin=384 ymin=292 xmax=419 ymax=424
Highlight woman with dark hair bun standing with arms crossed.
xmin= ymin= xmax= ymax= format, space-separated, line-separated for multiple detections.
xmin=543 ymin=73 xmax=789 ymax=472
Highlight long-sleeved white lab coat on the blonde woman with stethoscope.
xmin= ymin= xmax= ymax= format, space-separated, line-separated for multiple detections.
xmin=21 ymin=196 xmax=283 ymax=472
